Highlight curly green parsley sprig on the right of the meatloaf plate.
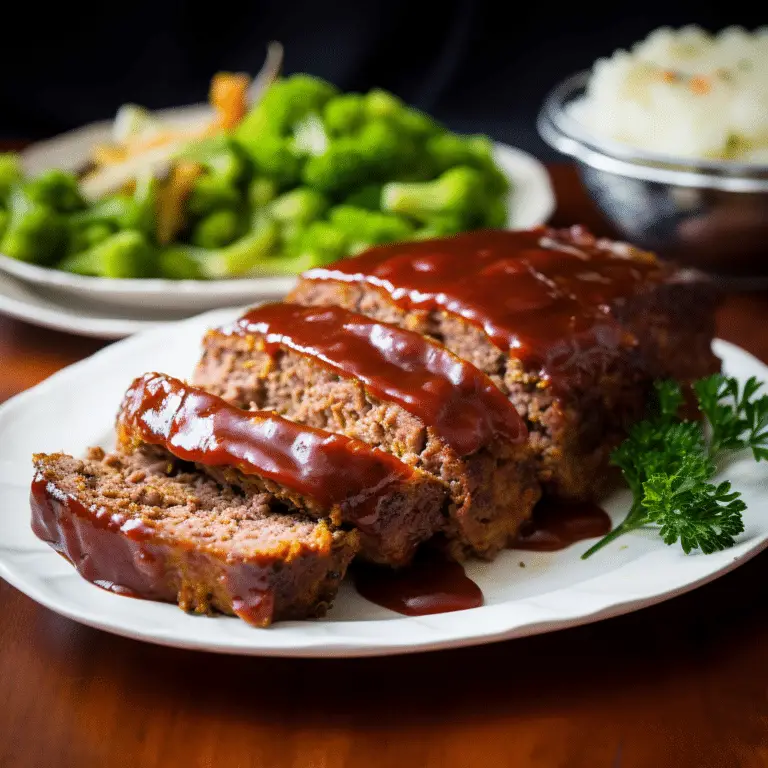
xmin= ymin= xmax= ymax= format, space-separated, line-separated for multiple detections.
xmin=582 ymin=374 xmax=768 ymax=558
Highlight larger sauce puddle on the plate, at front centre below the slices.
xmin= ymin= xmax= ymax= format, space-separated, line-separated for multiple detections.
xmin=354 ymin=550 xmax=483 ymax=616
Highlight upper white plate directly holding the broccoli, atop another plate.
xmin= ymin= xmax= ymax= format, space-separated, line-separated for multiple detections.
xmin=0 ymin=122 xmax=555 ymax=324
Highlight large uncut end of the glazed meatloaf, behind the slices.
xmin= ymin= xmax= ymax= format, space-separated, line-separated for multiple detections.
xmin=288 ymin=228 xmax=719 ymax=500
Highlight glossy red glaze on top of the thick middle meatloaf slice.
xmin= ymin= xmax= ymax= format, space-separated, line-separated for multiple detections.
xmin=220 ymin=304 xmax=526 ymax=456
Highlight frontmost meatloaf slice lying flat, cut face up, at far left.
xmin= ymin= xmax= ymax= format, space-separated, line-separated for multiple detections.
xmin=31 ymin=449 xmax=357 ymax=627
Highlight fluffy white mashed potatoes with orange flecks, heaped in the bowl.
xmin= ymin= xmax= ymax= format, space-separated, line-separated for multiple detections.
xmin=573 ymin=26 xmax=768 ymax=163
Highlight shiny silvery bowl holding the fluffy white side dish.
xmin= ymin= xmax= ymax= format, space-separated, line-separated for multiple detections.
xmin=537 ymin=72 xmax=768 ymax=284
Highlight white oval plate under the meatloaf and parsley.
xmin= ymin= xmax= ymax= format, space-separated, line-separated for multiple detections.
xmin=0 ymin=311 xmax=768 ymax=656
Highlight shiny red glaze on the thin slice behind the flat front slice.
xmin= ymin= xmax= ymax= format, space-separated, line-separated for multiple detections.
xmin=118 ymin=373 xmax=413 ymax=527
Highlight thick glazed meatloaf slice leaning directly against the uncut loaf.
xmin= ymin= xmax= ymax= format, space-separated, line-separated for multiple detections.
xmin=194 ymin=304 xmax=540 ymax=557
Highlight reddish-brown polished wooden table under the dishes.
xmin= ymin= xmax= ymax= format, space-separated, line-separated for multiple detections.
xmin=0 ymin=166 xmax=768 ymax=768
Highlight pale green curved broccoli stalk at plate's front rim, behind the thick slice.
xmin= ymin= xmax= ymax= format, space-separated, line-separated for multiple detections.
xmin=159 ymin=220 xmax=280 ymax=280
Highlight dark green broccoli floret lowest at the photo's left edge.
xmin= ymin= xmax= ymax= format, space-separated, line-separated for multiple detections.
xmin=0 ymin=200 xmax=67 ymax=266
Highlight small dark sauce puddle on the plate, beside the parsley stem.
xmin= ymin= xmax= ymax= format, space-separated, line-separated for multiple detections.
xmin=511 ymin=501 xmax=612 ymax=552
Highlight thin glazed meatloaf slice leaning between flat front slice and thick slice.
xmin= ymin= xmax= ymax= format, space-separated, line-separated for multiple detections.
xmin=117 ymin=373 xmax=445 ymax=565
